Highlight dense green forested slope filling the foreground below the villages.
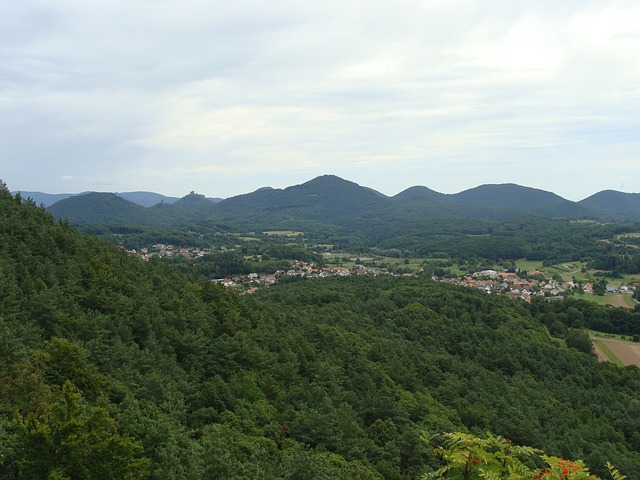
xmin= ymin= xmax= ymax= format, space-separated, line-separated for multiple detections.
xmin=5 ymin=183 xmax=640 ymax=479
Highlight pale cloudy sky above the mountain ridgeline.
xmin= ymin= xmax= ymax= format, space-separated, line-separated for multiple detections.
xmin=0 ymin=0 xmax=640 ymax=201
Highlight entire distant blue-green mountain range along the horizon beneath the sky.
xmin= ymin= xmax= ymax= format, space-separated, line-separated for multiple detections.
xmin=27 ymin=175 xmax=640 ymax=228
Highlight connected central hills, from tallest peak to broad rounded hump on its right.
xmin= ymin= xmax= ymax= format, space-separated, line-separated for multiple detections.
xmin=214 ymin=175 xmax=606 ymax=224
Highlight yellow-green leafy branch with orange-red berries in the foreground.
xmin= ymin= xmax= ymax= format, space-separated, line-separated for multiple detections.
xmin=421 ymin=432 xmax=626 ymax=480
